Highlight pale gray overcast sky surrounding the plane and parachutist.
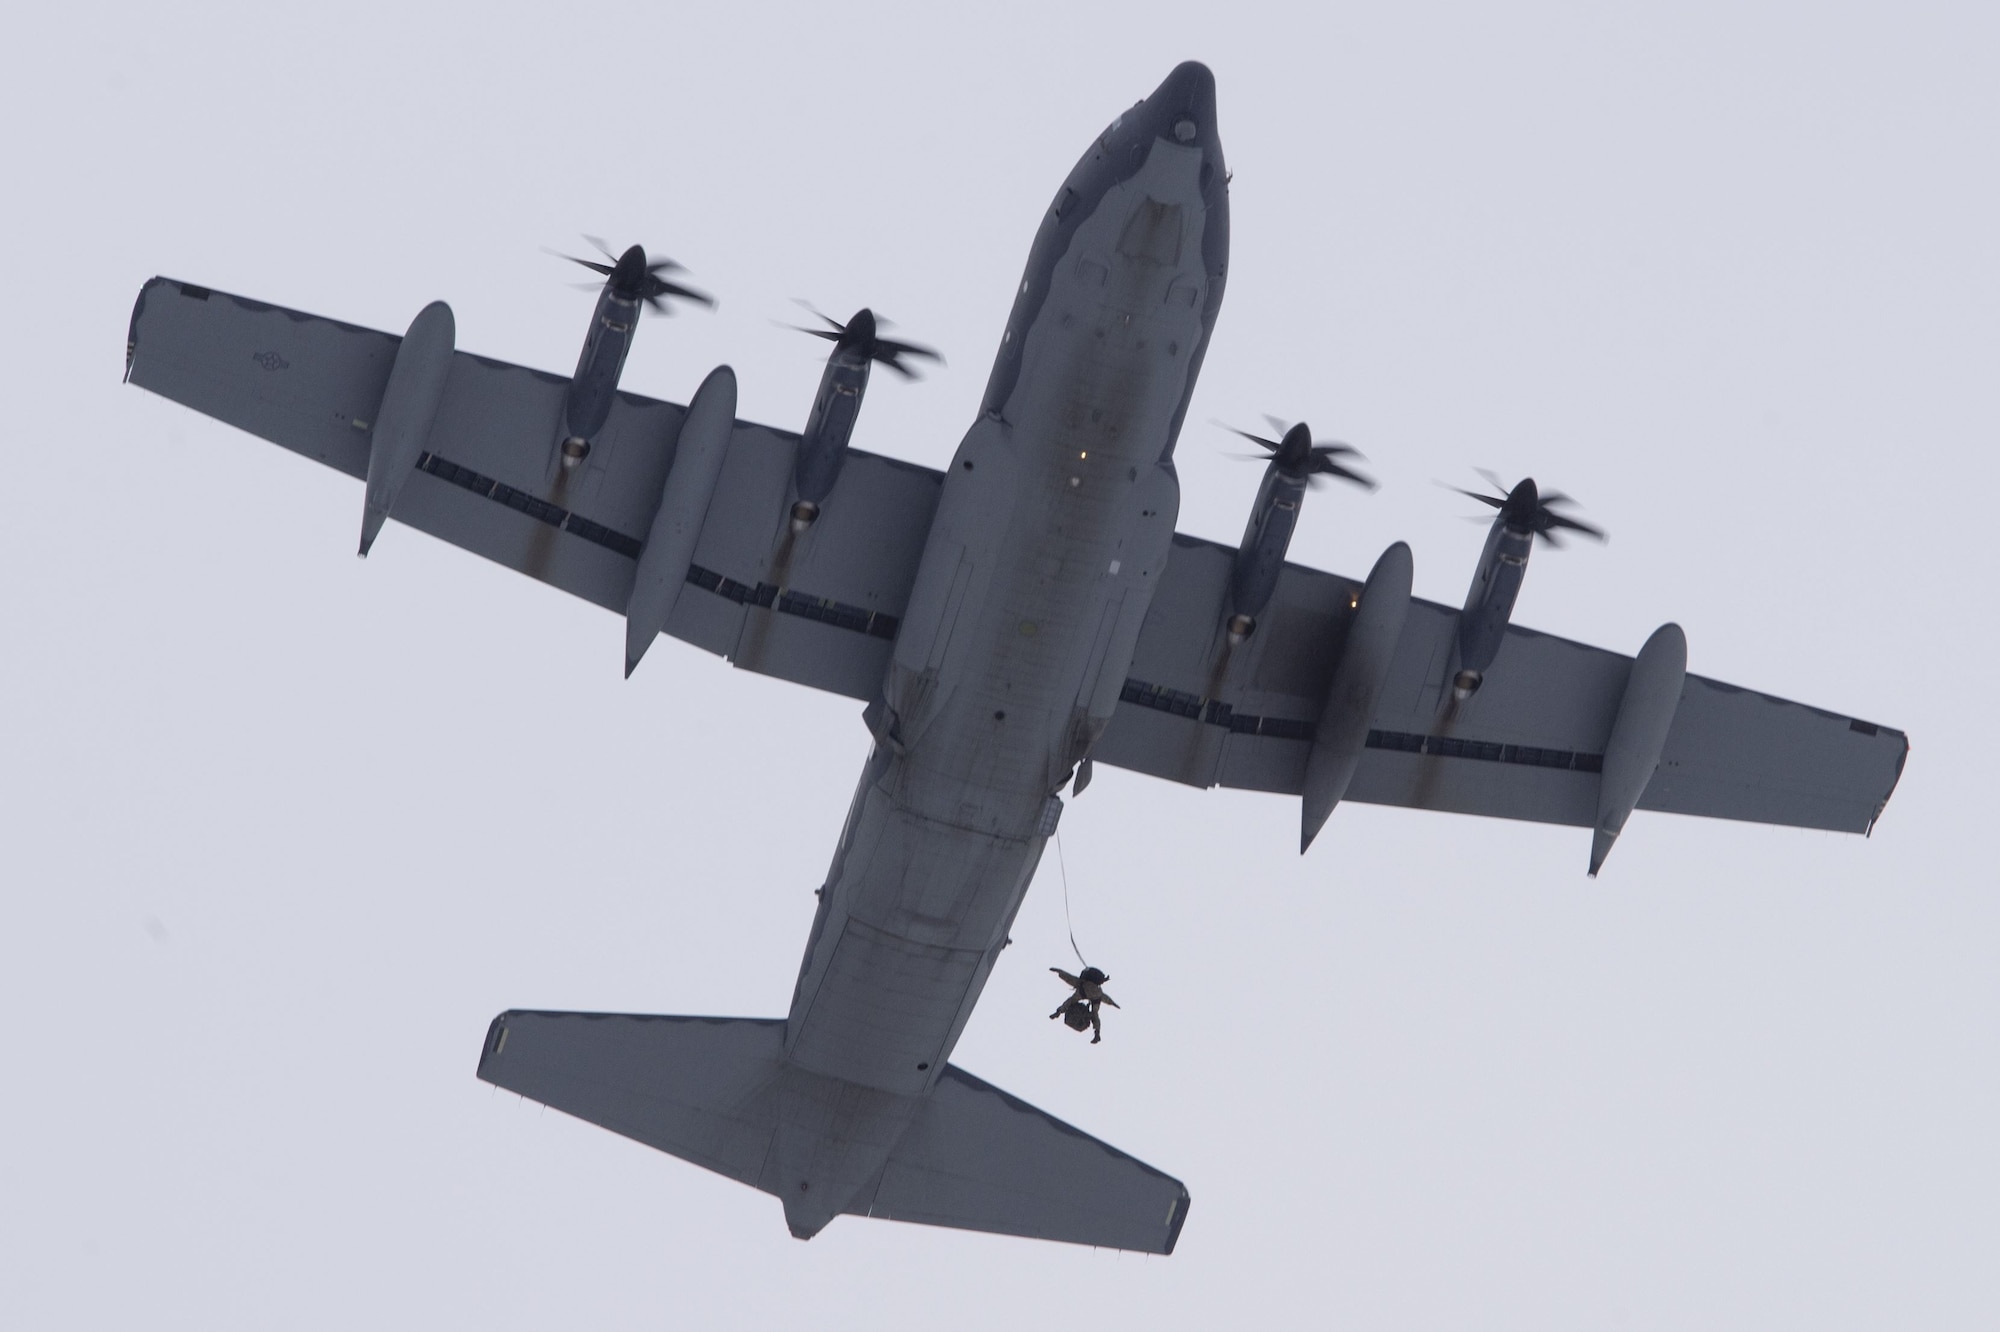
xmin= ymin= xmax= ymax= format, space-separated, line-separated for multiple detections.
xmin=0 ymin=0 xmax=2000 ymax=1330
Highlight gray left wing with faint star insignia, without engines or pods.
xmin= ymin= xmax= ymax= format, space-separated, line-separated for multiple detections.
xmin=126 ymin=278 xmax=940 ymax=700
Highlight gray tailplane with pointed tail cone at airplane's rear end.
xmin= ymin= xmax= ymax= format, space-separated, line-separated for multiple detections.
xmin=480 ymin=1012 xmax=1188 ymax=1254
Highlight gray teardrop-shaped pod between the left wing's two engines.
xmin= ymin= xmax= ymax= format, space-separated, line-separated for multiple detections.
xmin=626 ymin=366 xmax=736 ymax=680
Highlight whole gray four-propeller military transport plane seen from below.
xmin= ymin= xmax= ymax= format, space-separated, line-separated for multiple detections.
xmin=126 ymin=64 xmax=1908 ymax=1254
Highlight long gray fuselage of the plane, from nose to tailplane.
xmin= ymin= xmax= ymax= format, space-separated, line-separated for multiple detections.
xmin=784 ymin=64 xmax=1228 ymax=1096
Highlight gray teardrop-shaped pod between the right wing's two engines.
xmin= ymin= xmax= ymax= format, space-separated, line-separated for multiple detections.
xmin=1298 ymin=542 xmax=1416 ymax=856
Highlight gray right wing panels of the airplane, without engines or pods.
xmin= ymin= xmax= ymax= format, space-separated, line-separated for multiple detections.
xmin=1094 ymin=536 xmax=1910 ymax=832
